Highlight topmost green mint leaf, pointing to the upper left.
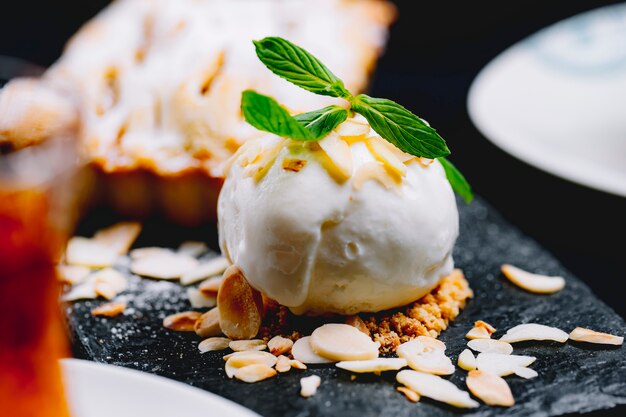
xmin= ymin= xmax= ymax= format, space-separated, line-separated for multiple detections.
xmin=253 ymin=37 xmax=352 ymax=99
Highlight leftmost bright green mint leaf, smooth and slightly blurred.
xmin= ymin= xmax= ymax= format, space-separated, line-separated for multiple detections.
xmin=241 ymin=90 xmax=316 ymax=140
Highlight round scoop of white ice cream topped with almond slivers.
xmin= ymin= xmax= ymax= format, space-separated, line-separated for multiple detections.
xmin=218 ymin=116 xmax=459 ymax=314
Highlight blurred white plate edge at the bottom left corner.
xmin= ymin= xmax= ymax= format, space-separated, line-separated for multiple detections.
xmin=61 ymin=359 xmax=259 ymax=417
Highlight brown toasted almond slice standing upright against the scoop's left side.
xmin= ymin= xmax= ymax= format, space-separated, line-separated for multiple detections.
xmin=217 ymin=265 xmax=263 ymax=340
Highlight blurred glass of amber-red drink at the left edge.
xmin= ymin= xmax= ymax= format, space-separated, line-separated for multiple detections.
xmin=0 ymin=76 xmax=81 ymax=417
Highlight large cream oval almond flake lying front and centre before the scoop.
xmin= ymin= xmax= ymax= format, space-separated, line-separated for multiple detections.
xmin=309 ymin=323 xmax=380 ymax=361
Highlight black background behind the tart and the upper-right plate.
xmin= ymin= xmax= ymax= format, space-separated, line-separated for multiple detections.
xmin=0 ymin=0 xmax=626 ymax=316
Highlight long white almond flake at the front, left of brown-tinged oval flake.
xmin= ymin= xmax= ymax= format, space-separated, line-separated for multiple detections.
xmin=396 ymin=369 xmax=479 ymax=408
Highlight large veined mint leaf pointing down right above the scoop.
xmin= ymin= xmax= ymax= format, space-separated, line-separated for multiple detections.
xmin=351 ymin=94 xmax=450 ymax=159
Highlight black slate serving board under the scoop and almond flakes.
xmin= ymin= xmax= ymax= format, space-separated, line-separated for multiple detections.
xmin=67 ymin=199 xmax=626 ymax=417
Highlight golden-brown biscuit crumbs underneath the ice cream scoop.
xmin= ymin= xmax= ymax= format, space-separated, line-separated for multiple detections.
xmin=260 ymin=269 xmax=473 ymax=354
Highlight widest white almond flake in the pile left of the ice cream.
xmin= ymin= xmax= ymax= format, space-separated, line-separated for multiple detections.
xmin=130 ymin=252 xmax=198 ymax=280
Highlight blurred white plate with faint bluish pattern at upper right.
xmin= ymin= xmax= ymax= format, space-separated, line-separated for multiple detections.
xmin=468 ymin=3 xmax=626 ymax=196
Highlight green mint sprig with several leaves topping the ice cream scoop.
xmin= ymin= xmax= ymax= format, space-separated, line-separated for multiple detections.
xmin=242 ymin=37 xmax=474 ymax=203
